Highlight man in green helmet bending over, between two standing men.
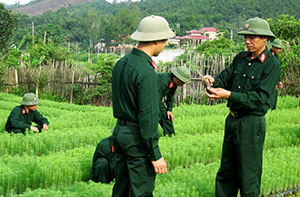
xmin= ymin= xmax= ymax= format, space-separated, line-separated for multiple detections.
xmin=158 ymin=66 xmax=191 ymax=137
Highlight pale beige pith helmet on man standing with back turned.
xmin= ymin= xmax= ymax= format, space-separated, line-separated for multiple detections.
xmin=131 ymin=15 xmax=175 ymax=42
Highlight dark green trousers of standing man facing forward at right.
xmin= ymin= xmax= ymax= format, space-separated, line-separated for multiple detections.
xmin=216 ymin=114 xmax=266 ymax=197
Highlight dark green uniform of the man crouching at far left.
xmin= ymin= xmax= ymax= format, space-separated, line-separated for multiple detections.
xmin=5 ymin=105 xmax=49 ymax=134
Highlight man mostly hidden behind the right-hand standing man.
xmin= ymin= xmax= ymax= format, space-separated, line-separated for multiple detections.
xmin=270 ymin=38 xmax=284 ymax=110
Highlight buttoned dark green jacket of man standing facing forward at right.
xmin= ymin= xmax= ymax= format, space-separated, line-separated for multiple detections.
xmin=213 ymin=48 xmax=280 ymax=115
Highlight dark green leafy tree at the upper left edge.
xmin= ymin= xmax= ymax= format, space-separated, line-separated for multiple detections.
xmin=0 ymin=3 xmax=18 ymax=54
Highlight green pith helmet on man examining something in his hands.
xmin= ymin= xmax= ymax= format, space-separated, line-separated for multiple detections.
xmin=238 ymin=17 xmax=275 ymax=38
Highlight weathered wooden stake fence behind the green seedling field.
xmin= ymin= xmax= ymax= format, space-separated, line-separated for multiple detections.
xmin=6 ymin=53 xmax=234 ymax=105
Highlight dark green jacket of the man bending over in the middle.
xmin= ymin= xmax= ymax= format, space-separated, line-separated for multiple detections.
xmin=158 ymin=73 xmax=177 ymax=111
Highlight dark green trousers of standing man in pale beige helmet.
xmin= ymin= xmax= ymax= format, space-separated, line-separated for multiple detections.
xmin=113 ymin=125 xmax=156 ymax=197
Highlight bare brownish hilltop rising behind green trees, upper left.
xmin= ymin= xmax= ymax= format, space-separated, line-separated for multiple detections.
xmin=15 ymin=0 xmax=94 ymax=16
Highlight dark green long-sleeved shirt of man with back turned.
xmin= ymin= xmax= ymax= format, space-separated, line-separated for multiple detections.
xmin=112 ymin=48 xmax=161 ymax=161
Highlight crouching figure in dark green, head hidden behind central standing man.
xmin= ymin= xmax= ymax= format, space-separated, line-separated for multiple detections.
xmin=92 ymin=136 xmax=115 ymax=183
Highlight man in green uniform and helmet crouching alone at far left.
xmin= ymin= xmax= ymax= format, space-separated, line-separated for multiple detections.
xmin=5 ymin=93 xmax=49 ymax=134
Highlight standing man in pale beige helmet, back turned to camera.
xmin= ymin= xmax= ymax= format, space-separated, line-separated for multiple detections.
xmin=112 ymin=15 xmax=175 ymax=197
